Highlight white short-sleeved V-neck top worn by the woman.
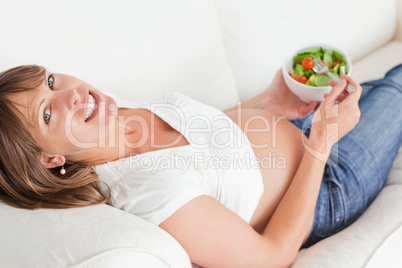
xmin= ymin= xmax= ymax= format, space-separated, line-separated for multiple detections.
xmin=95 ymin=92 xmax=264 ymax=225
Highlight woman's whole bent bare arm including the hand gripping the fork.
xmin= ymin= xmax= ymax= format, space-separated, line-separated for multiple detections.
xmin=159 ymin=77 xmax=361 ymax=267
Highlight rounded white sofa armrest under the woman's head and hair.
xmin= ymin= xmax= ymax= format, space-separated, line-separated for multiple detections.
xmin=0 ymin=203 xmax=191 ymax=268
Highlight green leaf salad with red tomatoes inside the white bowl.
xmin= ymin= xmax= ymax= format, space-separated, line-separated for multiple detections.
xmin=289 ymin=47 xmax=346 ymax=87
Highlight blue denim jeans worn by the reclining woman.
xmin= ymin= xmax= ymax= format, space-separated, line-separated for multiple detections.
xmin=290 ymin=64 xmax=402 ymax=248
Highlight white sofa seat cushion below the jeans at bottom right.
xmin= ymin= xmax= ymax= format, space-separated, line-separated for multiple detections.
xmin=292 ymin=185 xmax=402 ymax=268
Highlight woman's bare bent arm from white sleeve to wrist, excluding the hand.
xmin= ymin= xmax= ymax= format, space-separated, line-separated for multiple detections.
xmin=159 ymin=146 xmax=325 ymax=267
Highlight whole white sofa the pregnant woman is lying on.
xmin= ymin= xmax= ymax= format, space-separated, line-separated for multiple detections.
xmin=0 ymin=0 xmax=402 ymax=268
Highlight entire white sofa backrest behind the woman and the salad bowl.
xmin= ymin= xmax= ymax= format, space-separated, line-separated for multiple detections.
xmin=0 ymin=0 xmax=400 ymax=109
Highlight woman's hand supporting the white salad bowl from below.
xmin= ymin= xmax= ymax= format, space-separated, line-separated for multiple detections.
xmin=257 ymin=69 xmax=319 ymax=120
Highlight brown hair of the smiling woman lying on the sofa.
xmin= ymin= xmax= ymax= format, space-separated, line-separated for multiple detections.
xmin=0 ymin=65 xmax=110 ymax=209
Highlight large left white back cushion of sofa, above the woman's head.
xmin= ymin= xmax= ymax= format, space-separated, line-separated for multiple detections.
xmin=0 ymin=0 xmax=238 ymax=109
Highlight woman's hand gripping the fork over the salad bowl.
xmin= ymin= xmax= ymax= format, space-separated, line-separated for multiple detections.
xmin=308 ymin=75 xmax=362 ymax=158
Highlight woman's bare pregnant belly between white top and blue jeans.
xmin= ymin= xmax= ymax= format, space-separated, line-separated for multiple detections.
xmin=227 ymin=109 xmax=304 ymax=233
